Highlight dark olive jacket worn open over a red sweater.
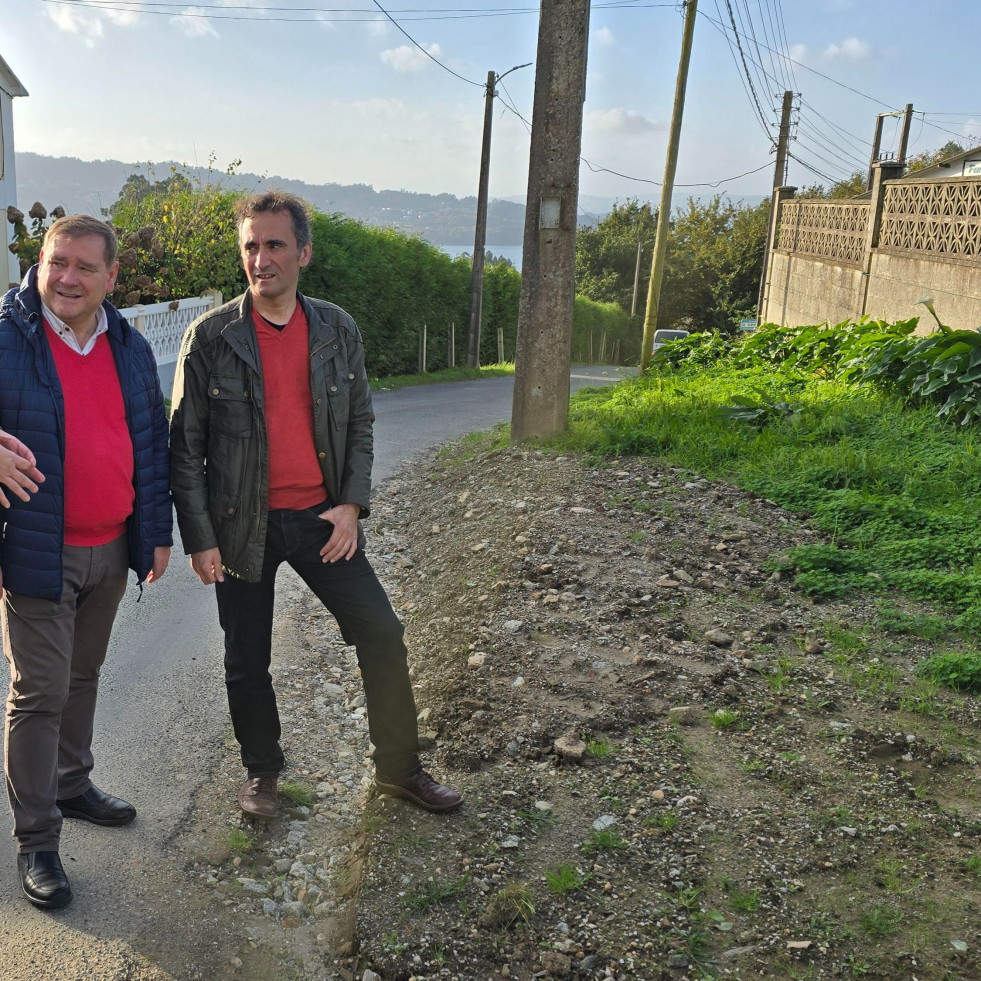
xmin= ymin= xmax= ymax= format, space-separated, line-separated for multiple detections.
xmin=170 ymin=293 xmax=375 ymax=582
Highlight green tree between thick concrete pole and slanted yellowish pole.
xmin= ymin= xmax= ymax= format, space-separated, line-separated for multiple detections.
xmin=576 ymin=198 xmax=657 ymax=311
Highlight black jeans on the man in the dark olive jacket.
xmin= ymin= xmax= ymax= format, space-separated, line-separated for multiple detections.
xmin=215 ymin=504 xmax=419 ymax=780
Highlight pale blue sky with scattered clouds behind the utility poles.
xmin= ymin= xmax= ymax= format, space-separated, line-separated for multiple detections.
xmin=0 ymin=0 xmax=981 ymax=214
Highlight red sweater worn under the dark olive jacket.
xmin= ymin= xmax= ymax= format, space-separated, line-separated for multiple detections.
xmin=252 ymin=303 xmax=327 ymax=511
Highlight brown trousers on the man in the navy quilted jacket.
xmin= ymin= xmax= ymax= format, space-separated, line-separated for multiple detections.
xmin=3 ymin=535 xmax=129 ymax=853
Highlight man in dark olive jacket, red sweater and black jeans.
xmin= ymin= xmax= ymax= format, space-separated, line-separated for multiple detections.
xmin=171 ymin=191 xmax=462 ymax=821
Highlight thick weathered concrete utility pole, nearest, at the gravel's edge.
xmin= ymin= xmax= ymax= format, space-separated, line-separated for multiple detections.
xmin=511 ymin=0 xmax=589 ymax=443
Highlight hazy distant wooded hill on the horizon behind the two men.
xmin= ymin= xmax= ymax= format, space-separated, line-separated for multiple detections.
xmin=16 ymin=153 xmax=525 ymax=247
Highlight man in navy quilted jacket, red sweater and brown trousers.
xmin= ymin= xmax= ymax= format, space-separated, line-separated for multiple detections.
xmin=0 ymin=215 xmax=172 ymax=909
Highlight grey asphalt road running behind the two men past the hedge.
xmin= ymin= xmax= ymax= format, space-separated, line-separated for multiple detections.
xmin=0 ymin=367 xmax=627 ymax=981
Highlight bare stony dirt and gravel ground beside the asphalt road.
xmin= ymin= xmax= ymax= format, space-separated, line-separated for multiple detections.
xmin=181 ymin=437 xmax=981 ymax=981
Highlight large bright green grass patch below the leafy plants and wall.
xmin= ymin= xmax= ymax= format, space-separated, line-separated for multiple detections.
xmin=556 ymin=362 xmax=981 ymax=648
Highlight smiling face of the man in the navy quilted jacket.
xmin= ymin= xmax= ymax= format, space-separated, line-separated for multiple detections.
xmin=37 ymin=235 xmax=119 ymax=333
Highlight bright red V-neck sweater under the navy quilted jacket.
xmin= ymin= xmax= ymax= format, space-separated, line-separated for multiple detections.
xmin=45 ymin=322 xmax=136 ymax=547
